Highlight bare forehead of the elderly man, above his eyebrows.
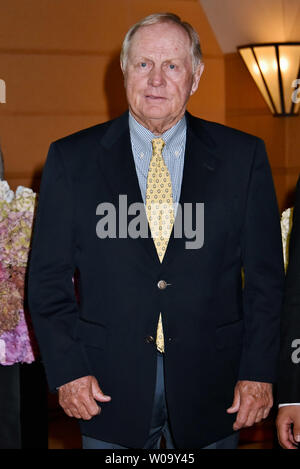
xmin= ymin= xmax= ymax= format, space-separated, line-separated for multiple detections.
xmin=129 ymin=23 xmax=191 ymax=57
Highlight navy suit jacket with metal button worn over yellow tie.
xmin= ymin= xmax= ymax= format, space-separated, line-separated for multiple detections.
xmin=29 ymin=113 xmax=284 ymax=448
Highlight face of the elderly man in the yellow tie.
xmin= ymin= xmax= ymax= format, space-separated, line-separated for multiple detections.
xmin=124 ymin=23 xmax=203 ymax=134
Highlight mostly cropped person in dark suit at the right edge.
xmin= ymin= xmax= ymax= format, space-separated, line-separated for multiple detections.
xmin=276 ymin=178 xmax=300 ymax=449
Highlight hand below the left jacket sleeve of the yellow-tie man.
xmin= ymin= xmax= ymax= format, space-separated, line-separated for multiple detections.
xmin=58 ymin=376 xmax=111 ymax=420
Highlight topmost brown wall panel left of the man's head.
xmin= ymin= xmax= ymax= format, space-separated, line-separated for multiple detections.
xmin=0 ymin=0 xmax=130 ymax=54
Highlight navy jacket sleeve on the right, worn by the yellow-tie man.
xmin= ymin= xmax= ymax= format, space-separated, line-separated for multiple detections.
xmin=239 ymin=139 xmax=284 ymax=382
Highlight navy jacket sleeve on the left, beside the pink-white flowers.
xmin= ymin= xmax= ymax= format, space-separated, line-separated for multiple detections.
xmin=28 ymin=143 xmax=90 ymax=391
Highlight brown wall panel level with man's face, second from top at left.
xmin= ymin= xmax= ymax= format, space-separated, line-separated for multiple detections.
xmin=1 ymin=53 xmax=125 ymax=115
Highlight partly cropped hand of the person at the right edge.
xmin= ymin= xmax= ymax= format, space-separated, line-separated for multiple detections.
xmin=276 ymin=405 xmax=300 ymax=449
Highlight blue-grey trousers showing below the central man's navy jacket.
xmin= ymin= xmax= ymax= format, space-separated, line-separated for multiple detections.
xmin=82 ymin=352 xmax=239 ymax=449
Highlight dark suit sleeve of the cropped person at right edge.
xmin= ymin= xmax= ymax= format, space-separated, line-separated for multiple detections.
xmin=278 ymin=178 xmax=300 ymax=403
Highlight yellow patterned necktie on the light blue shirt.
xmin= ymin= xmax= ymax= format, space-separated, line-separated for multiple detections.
xmin=146 ymin=138 xmax=174 ymax=352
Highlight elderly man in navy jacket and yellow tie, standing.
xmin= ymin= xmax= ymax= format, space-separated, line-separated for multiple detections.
xmin=29 ymin=14 xmax=284 ymax=448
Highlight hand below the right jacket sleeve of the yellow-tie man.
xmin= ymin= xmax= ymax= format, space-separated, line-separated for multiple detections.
xmin=227 ymin=381 xmax=273 ymax=430
